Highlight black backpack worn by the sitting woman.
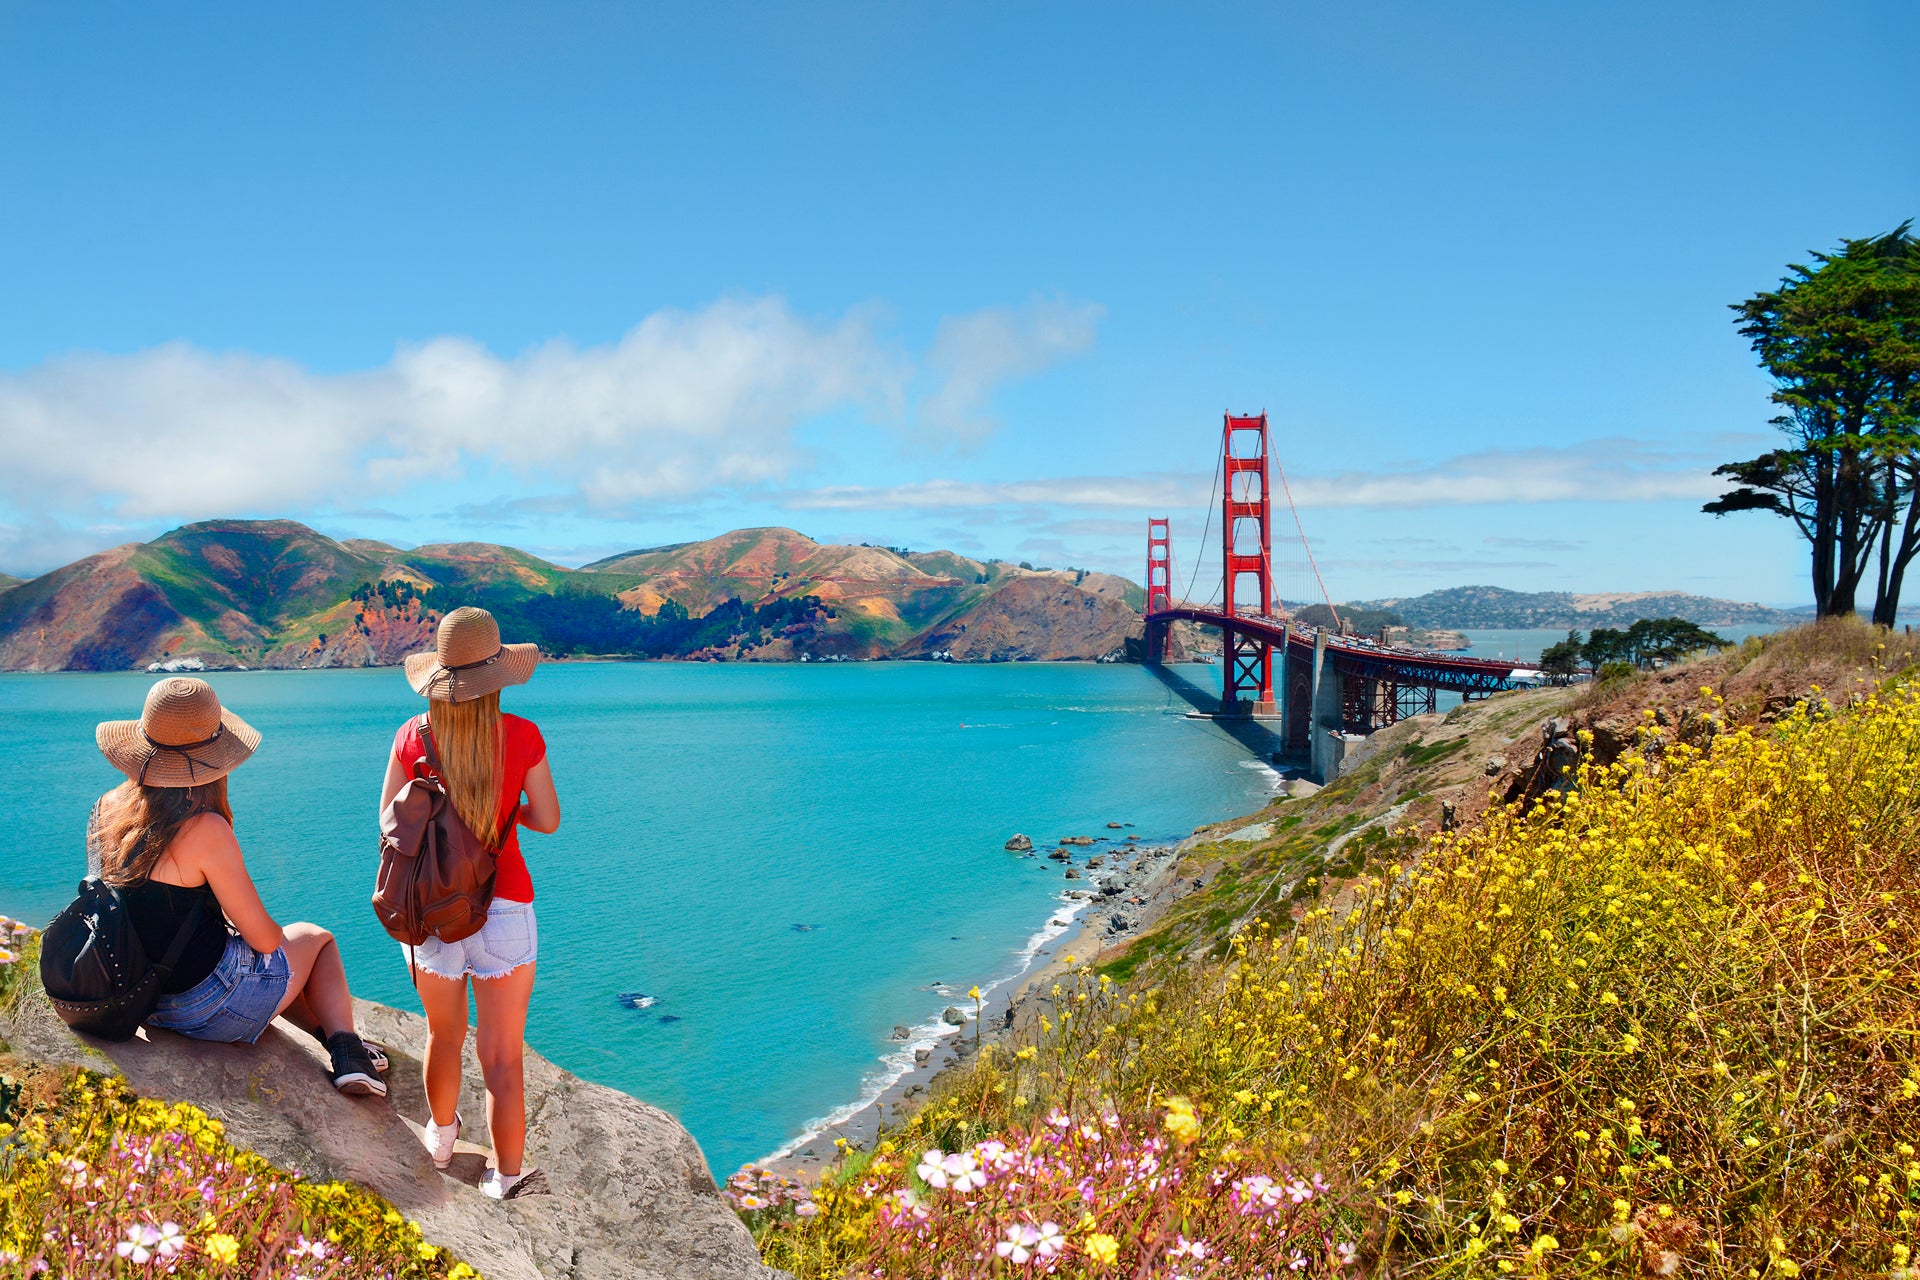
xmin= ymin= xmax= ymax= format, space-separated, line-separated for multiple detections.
xmin=40 ymin=875 xmax=205 ymax=1040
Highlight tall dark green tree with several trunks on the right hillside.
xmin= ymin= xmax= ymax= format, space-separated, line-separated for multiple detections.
xmin=1705 ymin=221 xmax=1920 ymax=626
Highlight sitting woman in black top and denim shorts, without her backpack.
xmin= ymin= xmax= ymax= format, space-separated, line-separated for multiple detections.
xmin=86 ymin=676 xmax=386 ymax=1096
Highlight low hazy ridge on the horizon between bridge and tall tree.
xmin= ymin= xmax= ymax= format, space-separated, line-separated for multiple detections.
xmin=1352 ymin=587 xmax=1812 ymax=631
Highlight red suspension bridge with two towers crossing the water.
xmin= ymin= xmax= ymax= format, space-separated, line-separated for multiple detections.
xmin=1144 ymin=413 xmax=1538 ymax=781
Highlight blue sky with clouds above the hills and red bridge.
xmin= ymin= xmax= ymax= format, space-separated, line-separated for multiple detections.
xmin=0 ymin=0 xmax=1920 ymax=603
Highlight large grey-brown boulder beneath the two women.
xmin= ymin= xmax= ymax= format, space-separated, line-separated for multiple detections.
xmin=0 ymin=990 xmax=783 ymax=1280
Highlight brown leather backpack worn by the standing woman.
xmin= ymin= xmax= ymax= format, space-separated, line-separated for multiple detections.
xmin=372 ymin=716 xmax=518 ymax=946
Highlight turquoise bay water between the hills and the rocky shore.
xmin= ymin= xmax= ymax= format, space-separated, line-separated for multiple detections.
xmin=0 ymin=662 xmax=1273 ymax=1176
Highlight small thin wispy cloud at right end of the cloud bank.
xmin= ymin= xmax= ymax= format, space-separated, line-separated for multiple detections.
xmin=920 ymin=299 xmax=1106 ymax=447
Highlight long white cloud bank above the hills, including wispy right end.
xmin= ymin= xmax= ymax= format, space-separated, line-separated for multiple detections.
xmin=0 ymin=297 xmax=1098 ymax=520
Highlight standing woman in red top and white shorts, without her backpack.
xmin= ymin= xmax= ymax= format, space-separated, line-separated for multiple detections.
xmin=380 ymin=608 xmax=561 ymax=1199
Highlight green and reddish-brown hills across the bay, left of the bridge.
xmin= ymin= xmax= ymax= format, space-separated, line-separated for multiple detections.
xmin=0 ymin=520 xmax=1142 ymax=672
